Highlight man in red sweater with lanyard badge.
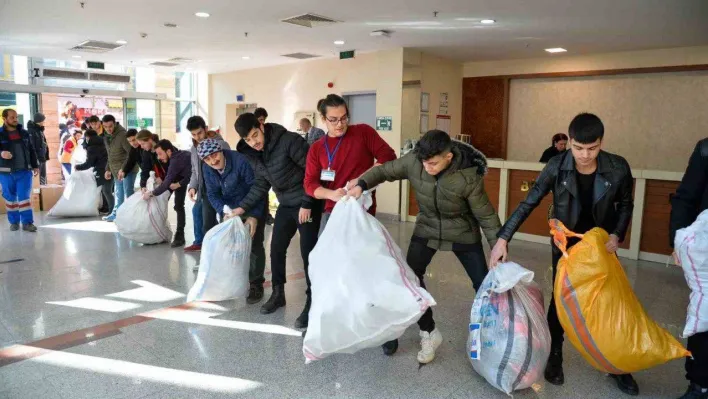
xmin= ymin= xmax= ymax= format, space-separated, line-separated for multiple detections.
xmin=305 ymin=94 xmax=396 ymax=229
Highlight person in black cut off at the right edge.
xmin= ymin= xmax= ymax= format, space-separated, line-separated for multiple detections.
xmin=669 ymin=139 xmax=708 ymax=399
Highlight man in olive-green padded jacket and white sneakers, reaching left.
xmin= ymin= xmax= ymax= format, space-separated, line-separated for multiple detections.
xmin=348 ymin=130 xmax=501 ymax=364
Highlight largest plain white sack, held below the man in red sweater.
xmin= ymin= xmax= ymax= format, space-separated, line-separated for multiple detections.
xmin=302 ymin=193 xmax=435 ymax=362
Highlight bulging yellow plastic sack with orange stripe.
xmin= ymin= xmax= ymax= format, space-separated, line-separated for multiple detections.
xmin=549 ymin=219 xmax=691 ymax=374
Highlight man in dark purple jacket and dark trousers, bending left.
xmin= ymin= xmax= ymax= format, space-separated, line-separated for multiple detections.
xmin=143 ymin=140 xmax=192 ymax=248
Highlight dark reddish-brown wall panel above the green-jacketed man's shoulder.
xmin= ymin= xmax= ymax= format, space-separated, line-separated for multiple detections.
xmin=462 ymin=78 xmax=509 ymax=159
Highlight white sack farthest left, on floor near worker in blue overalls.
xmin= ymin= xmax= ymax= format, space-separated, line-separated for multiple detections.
xmin=47 ymin=168 xmax=101 ymax=218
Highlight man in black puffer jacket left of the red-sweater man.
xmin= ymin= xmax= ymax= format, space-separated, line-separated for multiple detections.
xmin=235 ymin=113 xmax=322 ymax=328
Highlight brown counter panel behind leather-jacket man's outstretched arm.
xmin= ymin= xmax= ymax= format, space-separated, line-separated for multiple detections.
xmin=507 ymin=170 xmax=553 ymax=237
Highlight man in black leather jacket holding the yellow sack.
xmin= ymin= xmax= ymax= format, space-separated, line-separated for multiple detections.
xmin=490 ymin=113 xmax=639 ymax=396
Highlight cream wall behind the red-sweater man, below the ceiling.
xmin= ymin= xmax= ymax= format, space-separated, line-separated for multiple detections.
xmin=209 ymin=48 xmax=403 ymax=214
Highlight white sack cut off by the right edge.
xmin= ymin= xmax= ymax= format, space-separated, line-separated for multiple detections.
xmin=674 ymin=211 xmax=708 ymax=338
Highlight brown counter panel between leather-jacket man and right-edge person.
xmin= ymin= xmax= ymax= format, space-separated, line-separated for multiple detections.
xmin=639 ymin=180 xmax=679 ymax=255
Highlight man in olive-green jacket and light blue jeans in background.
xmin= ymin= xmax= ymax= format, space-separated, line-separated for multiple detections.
xmin=103 ymin=115 xmax=138 ymax=222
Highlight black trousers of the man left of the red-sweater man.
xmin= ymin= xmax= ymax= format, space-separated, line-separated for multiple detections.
xmin=270 ymin=204 xmax=322 ymax=295
